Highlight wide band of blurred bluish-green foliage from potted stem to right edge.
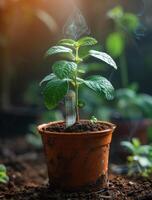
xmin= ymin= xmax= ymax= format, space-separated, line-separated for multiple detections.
xmin=81 ymin=88 xmax=152 ymax=120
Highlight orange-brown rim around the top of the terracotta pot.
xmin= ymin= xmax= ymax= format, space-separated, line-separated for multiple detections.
xmin=37 ymin=119 xmax=116 ymax=136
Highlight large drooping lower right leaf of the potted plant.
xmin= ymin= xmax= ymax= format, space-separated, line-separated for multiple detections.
xmin=83 ymin=76 xmax=114 ymax=100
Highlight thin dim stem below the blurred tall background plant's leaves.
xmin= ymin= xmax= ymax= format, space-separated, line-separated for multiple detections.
xmin=120 ymin=53 xmax=128 ymax=88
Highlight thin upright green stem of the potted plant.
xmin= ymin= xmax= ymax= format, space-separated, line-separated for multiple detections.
xmin=75 ymin=47 xmax=80 ymax=122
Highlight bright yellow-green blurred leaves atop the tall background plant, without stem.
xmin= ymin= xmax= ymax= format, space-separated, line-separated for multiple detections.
xmin=106 ymin=6 xmax=140 ymax=58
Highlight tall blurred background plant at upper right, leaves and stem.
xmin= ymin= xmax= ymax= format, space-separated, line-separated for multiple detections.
xmin=106 ymin=6 xmax=140 ymax=88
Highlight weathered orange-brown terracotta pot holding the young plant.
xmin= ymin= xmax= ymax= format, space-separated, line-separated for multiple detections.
xmin=38 ymin=121 xmax=115 ymax=191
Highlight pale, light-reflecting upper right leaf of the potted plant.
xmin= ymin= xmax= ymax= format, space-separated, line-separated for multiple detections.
xmin=89 ymin=50 xmax=117 ymax=69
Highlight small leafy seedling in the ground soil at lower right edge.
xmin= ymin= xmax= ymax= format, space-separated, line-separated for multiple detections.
xmin=121 ymin=138 xmax=152 ymax=177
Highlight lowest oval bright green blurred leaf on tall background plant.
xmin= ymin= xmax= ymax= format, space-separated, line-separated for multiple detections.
xmin=106 ymin=32 xmax=125 ymax=57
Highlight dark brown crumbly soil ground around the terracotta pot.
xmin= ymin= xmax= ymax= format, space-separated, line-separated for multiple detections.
xmin=0 ymin=138 xmax=152 ymax=200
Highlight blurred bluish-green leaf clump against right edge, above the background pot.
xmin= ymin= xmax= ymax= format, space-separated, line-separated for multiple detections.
xmin=113 ymin=88 xmax=152 ymax=119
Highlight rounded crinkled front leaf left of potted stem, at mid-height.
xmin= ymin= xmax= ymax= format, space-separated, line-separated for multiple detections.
xmin=52 ymin=60 xmax=77 ymax=79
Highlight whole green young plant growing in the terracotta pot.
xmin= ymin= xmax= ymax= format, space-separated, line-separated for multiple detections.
xmin=40 ymin=37 xmax=117 ymax=122
